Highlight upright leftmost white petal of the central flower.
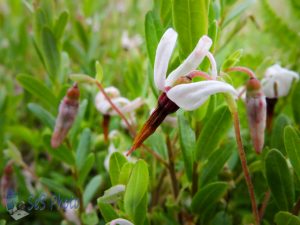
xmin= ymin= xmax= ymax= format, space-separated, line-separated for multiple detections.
xmin=154 ymin=28 xmax=177 ymax=91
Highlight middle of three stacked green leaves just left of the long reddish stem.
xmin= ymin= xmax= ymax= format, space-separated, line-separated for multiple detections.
xmin=199 ymin=144 xmax=234 ymax=186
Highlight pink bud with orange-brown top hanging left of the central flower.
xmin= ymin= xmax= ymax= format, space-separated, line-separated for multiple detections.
xmin=51 ymin=83 xmax=80 ymax=148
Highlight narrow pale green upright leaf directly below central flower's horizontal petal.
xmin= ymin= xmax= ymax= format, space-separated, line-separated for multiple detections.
xmin=178 ymin=110 xmax=196 ymax=181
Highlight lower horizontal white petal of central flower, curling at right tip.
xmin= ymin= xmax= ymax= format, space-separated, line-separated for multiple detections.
xmin=167 ymin=80 xmax=237 ymax=110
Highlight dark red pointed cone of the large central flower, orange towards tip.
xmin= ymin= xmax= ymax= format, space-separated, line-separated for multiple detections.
xmin=127 ymin=92 xmax=179 ymax=155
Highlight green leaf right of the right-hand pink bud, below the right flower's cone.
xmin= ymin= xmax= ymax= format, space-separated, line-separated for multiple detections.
xmin=271 ymin=114 xmax=290 ymax=155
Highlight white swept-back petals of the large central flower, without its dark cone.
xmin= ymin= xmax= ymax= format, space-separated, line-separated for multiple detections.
xmin=154 ymin=28 xmax=236 ymax=110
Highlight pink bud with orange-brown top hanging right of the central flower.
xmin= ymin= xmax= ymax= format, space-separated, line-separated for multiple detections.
xmin=246 ymin=78 xmax=267 ymax=154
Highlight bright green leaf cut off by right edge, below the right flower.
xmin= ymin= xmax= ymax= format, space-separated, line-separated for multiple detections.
xmin=284 ymin=126 xmax=300 ymax=177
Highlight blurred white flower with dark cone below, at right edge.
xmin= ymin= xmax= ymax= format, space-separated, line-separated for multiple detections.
xmin=261 ymin=64 xmax=299 ymax=98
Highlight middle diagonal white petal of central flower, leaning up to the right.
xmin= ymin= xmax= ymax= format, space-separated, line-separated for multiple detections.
xmin=165 ymin=35 xmax=212 ymax=87
